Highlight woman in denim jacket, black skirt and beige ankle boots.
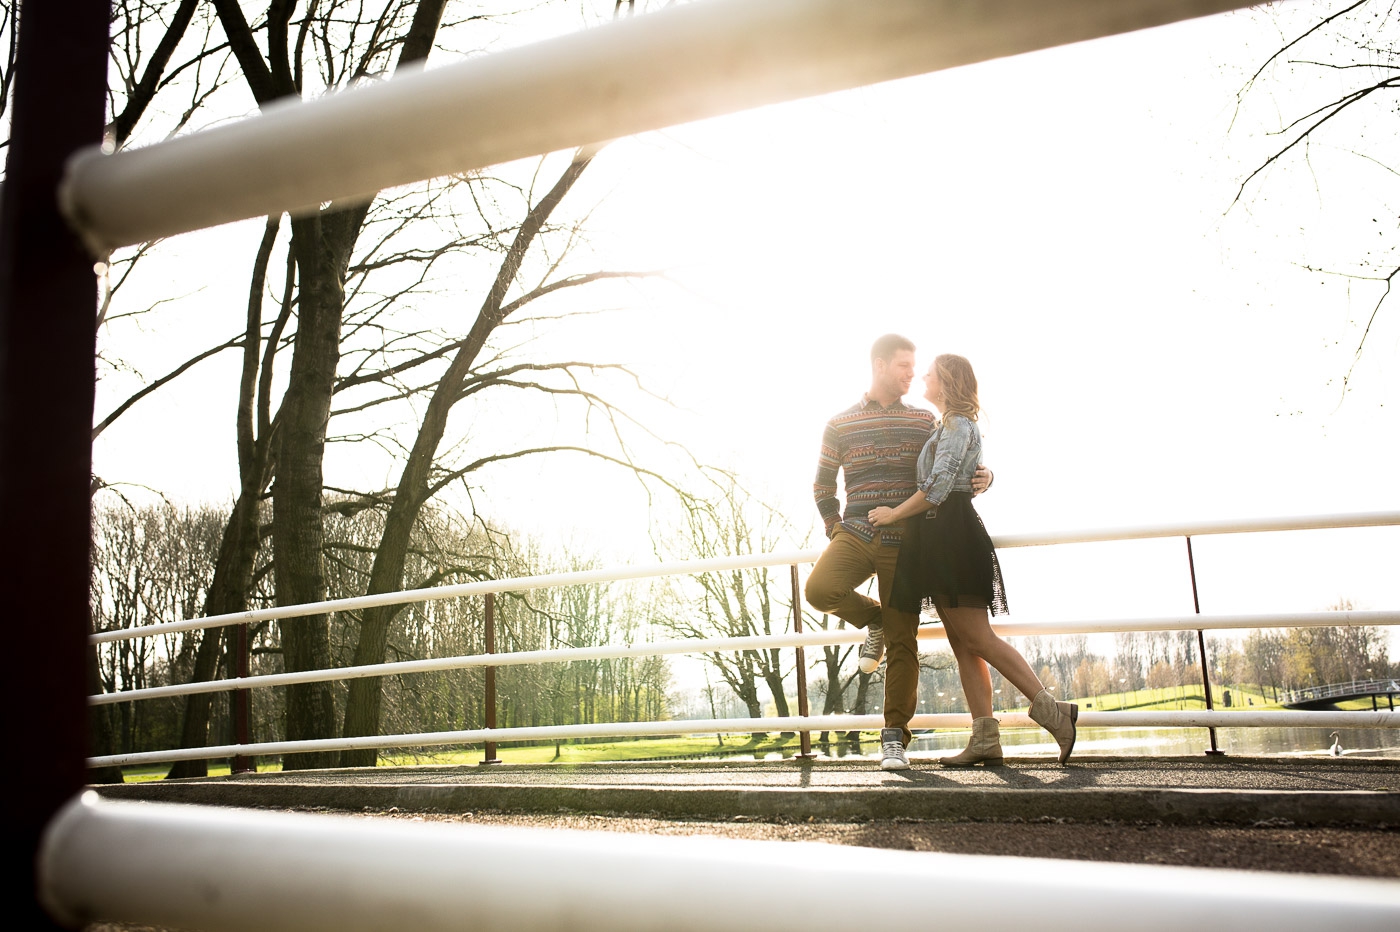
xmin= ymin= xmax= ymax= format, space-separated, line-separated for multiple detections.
xmin=869 ymin=354 xmax=1079 ymax=767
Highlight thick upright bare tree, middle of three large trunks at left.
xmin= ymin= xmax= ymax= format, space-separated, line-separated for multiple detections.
xmin=193 ymin=0 xmax=459 ymax=770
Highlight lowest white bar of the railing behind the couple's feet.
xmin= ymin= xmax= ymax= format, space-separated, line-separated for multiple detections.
xmin=88 ymin=711 xmax=1400 ymax=767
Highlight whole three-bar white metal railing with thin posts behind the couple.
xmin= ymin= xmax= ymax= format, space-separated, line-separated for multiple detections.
xmin=88 ymin=512 xmax=1400 ymax=767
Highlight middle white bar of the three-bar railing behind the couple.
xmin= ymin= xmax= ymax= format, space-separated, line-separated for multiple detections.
xmin=88 ymin=612 xmax=1400 ymax=705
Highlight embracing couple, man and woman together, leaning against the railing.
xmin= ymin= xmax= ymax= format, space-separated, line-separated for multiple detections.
xmin=806 ymin=333 xmax=1079 ymax=770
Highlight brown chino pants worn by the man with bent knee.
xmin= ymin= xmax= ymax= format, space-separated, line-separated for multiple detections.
xmin=806 ymin=528 xmax=918 ymax=746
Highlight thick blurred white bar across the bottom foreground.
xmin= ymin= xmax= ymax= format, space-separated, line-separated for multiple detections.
xmin=36 ymin=792 xmax=1400 ymax=932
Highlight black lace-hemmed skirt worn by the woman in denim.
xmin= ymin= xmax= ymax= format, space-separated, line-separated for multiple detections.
xmin=890 ymin=491 xmax=1007 ymax=614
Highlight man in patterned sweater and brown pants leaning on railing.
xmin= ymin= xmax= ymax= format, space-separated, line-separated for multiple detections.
xmin=806 ymin=333 xmax=991 ymax=770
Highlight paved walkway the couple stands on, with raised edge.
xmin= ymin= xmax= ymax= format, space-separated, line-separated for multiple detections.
xmin=98 ymin=757 xmax=1400 ymax=826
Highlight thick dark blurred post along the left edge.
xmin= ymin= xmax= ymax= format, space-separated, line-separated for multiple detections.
xmin=0 ymin=0 xmax=108 ymax=929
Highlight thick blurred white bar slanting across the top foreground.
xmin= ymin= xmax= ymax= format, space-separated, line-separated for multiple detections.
xmin=60 ymin=0 xmax=1250 ymax=255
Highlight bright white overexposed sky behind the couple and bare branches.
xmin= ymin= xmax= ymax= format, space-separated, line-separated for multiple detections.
xmin=95 ymin=3 xmax=1400 ymax=638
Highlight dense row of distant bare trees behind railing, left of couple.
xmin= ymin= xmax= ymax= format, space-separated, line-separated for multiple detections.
xmin=92 ymin=502 xmax=671 ymax=753
